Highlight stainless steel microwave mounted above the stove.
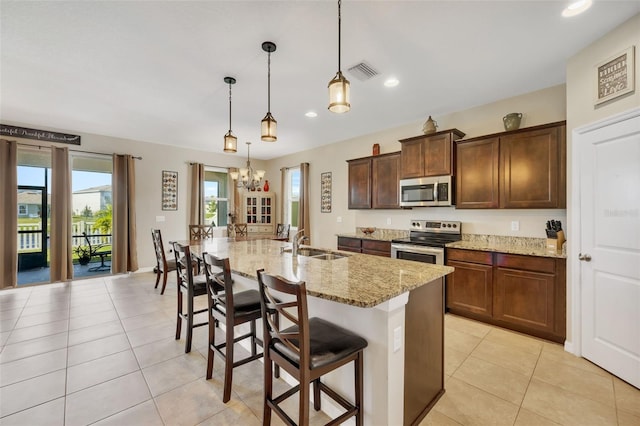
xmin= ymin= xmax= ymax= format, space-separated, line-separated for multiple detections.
xmin=400 ymin=176 xmax=454 ymax=207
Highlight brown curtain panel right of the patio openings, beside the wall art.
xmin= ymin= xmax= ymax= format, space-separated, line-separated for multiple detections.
xmin=111 ymin=154 xmax=138 ymax=274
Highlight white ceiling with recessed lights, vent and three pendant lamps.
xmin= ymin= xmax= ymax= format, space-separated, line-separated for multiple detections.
xmin=0 ymin=0 xmax=640 ymax=159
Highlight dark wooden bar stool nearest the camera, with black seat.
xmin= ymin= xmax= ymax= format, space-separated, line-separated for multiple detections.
xmin=257 ymin=269 xmax=367 ymax=426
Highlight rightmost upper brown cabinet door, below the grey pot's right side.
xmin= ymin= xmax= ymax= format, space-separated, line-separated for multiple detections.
xmin=500 ymin=127 xmax=560 ymax=209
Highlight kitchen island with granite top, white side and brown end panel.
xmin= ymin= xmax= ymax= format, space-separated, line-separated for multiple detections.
xmin=190 ymin=238 xmax=453 ymax=425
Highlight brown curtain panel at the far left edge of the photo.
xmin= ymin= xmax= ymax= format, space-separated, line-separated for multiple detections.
xmin=0 ymin=140 xmax=18 ymax=288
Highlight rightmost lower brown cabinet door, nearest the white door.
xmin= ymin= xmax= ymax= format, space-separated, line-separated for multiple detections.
xmin=493 ymin=267 xmax=556 ymax=333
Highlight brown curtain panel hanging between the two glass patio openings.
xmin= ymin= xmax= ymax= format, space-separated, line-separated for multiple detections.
xmin=49 ymin=147 xmax=73 ymax=282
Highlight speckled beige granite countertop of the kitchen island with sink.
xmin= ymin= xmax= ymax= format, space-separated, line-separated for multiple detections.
xmin=190 ymin=238 xmax=453 ymax=308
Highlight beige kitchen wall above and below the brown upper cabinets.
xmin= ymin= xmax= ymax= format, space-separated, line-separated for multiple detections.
xmin=267 ymin=85 xmax=566 ymax=247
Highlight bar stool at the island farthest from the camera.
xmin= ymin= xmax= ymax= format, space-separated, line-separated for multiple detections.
xmin=173 ymin=243 xmax=208 ymax=353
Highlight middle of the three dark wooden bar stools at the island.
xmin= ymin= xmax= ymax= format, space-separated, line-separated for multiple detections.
xmin=202 ymin=253 xmax=274 ymax=403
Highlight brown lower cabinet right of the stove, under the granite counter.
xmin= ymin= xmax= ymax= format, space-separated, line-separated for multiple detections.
xmin=446 ymin=249 xmax=566 ymax=343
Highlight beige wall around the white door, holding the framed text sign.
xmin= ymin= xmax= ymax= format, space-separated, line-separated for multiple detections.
xmin=567 ymin=14 xmax=640 ymax=342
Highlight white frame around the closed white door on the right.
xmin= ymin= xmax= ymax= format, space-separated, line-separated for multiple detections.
xmin=564 ymin=107 xmax=640 ymax=356
